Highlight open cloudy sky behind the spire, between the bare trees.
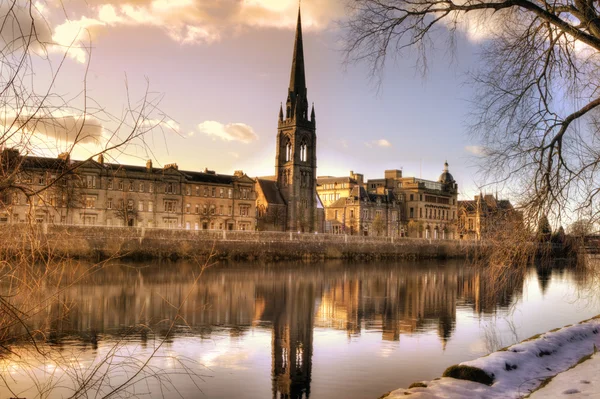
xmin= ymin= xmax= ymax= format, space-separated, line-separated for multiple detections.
xmin=0 ymin=0 xmax=494 ymax=198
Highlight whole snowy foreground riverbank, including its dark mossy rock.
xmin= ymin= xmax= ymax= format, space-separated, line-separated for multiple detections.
xmin=381 ymin=316 xmax=600 ymax=399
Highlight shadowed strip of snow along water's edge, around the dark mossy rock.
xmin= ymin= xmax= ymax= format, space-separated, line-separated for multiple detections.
xmin=386 ymin=318 xmax=600 ymax=399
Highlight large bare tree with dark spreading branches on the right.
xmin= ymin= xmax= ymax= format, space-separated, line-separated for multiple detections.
xmin=346 ymin=0 xmax=600 ymax=228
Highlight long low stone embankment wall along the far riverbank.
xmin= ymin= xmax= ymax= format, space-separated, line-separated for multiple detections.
xmin=0 ymin=225 xmax=478 ymax=261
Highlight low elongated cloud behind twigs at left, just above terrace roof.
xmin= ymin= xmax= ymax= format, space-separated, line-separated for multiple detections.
xmin=0 ymin=113 xmax=104 ymax=144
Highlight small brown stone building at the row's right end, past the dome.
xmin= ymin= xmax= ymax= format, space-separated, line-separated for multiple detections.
xmin=458 ymin=194 xmax=522 ymax=240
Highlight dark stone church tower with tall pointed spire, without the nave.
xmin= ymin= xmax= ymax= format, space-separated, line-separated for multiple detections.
xmin=275 ymin=5 xmax=319 ymax=232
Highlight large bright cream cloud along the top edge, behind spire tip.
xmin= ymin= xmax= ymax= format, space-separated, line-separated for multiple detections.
xmin=43 ymin=0 xmax=344 ymax=62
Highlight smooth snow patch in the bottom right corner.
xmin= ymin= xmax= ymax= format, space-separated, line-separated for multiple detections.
xmin=531 ymin=352 xmax=600 ymax=399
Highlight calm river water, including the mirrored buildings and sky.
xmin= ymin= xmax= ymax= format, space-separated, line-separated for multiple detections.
xmin=0 ymin=261 xmax=600 ymax=399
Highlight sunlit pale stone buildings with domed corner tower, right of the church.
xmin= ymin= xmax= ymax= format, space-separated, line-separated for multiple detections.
xmin=318 ymin=163 xmax=458 ymax=239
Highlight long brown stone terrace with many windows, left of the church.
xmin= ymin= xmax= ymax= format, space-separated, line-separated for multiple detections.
xmin=0 ymin=150 xmax=256 ymax=230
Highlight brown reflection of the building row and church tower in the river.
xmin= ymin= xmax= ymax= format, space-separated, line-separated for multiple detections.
xmin=0 ymin=262 xmax=592 ymax=399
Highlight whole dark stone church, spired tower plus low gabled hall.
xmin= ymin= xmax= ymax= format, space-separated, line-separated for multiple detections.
xmin=256 ymin=10 xmax=324 ymax=232
